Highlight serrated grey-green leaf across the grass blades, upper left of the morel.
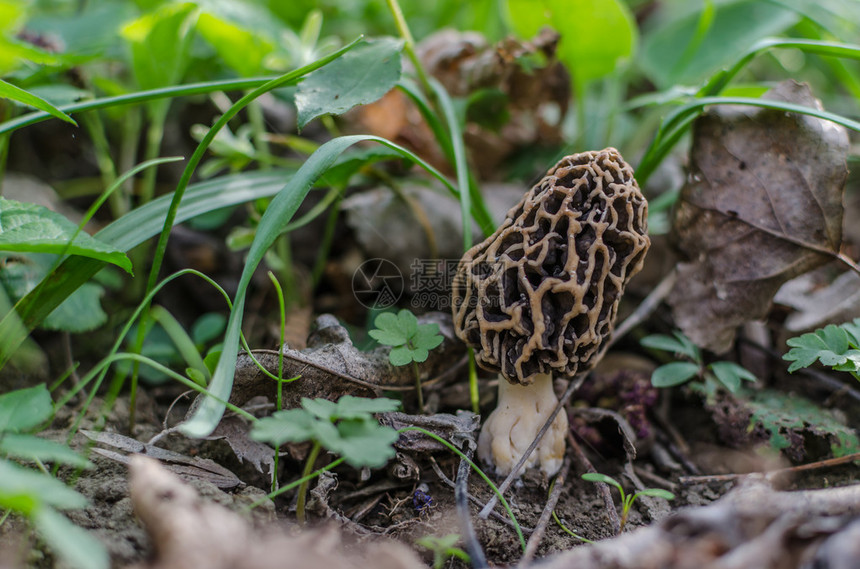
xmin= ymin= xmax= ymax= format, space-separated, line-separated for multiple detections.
xmin=296 ymin=38 xmax=403 ymax=128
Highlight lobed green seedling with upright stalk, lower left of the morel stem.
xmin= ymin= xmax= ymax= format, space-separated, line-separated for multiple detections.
xmin=251 ymin=395 xmax=400 ymax=524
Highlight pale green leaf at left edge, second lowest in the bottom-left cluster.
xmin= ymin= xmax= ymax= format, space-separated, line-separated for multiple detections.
xmin=0 ymin=460 xmax=87 ymax=514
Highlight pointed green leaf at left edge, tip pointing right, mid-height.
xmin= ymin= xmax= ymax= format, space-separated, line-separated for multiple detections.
xmin=0 ymin=197 xmax=131 ymax=273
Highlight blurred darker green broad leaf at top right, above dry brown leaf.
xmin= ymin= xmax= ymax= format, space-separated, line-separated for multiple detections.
xmin=640 ymin=0 xmax=799 ymax=89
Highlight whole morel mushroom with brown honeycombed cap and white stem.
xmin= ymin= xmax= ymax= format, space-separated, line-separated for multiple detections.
xmin=452 ymin=148 xmax=651 ymax=475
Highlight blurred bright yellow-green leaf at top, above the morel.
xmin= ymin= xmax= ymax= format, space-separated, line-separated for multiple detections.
xmin=507 ymin=0 xmax=636 ymax=84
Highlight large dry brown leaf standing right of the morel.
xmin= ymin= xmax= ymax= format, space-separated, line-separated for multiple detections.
xmin=669 ymin=81 xmax=848 ymax=352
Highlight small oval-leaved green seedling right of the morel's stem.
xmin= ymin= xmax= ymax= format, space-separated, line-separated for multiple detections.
xmin=640 ymin=331 xmax=756 ymax=393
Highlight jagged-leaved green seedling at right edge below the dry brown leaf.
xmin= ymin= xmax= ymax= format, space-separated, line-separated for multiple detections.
xmin=782 ymin=318 xmax=860 ymax=380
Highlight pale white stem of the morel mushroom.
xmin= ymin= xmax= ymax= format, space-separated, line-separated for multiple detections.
xmin=478 ymin=374 xmax=568 ymax=476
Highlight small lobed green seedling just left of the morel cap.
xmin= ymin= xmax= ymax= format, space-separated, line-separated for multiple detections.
xmin=369 ymin=308 xmax=444 ymax=410
